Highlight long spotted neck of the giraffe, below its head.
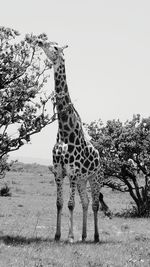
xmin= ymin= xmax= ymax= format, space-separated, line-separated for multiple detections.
xmin=54 ymin=59 xmax=82 ymax=143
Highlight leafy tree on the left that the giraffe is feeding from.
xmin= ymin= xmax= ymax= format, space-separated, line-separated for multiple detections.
xmin=0 ymin=27 xmax=55 ymax=178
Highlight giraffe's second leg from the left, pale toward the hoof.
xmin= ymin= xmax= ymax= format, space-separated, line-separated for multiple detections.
xmin=68 ymin=177 xmax=76 ymax=243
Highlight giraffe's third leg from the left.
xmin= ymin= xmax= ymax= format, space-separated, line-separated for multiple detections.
xmin=77 ymin=180 xmax=89 ymax=241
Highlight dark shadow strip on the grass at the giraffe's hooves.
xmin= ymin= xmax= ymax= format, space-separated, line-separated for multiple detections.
xmin=0 ymin=235 xmax=122 ymax=246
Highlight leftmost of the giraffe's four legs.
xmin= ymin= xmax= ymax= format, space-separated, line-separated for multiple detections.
xmin=55 ymin=177 xmax=63 ymax=241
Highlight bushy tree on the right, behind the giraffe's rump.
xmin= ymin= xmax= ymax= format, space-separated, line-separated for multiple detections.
xmin=88 ymin=115 xmax=150 ymax=216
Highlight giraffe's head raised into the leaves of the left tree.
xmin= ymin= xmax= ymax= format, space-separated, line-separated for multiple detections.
xmin=37 ymin=40 xmax=68 ymax=64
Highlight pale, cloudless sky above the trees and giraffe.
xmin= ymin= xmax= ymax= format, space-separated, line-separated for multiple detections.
xmin=0 ymin=0 xmax=150 ymax=162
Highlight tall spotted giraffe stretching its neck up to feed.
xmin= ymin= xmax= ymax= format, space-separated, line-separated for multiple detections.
xmin=37 ymin=40 xmax=103 ymax=242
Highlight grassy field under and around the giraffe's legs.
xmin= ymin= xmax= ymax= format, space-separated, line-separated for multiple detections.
xmin=0 ymin=164 xmax=150 ymax=267
